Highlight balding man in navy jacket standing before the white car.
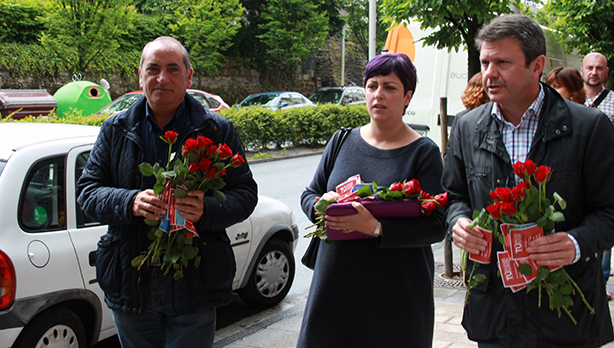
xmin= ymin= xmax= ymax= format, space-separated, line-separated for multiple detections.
xmin=77 ymin=37 xmax=258 ymax=348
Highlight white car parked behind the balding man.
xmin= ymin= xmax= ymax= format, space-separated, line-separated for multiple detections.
xmin=0 ymin=123 xmax=298 ymax=348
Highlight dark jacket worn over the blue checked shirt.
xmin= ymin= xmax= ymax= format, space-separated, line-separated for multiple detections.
xmin=442 ymin=84 xmax=614 ymax=348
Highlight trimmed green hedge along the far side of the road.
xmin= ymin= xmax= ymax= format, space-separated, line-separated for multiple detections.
xmin=0 ymin=104 xmax=369 ymax=150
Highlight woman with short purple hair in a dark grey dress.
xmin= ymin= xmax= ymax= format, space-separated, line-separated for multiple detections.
xmin=297 ymin=54 xmax=445 ymax=348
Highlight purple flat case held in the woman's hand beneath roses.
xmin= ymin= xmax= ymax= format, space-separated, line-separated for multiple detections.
xmin=326 ymin=199 xmax=420 ymax=240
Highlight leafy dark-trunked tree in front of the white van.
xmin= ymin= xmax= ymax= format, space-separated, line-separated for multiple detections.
xmin=382 ymin=0 xmax=519 ymax=79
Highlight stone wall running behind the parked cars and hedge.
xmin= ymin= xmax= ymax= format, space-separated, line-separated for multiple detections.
xmin=0 ymin=38 xmax=367 ymax=105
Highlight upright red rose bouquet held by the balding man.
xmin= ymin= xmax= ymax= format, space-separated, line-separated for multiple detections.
xmin=132 ymin=131 xmax=245 ymax=279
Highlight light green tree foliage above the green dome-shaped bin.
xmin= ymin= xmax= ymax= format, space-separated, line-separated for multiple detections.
xmin=41 ymin=0 xmax=135 ymax=73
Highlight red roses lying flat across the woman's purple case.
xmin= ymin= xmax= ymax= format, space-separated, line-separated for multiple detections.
xmin=305 ymin=176 xmax=448 ymax=243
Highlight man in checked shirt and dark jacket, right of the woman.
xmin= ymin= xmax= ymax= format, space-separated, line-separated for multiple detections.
xmin=442 ymin=15 xmax=614 ymax=348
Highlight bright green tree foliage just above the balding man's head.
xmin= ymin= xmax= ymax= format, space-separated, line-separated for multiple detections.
xmin=169 ymin=0 xmax=243 ymax=75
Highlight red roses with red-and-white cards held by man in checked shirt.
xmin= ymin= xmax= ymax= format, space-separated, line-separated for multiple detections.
xmin=468 ymin=160 xmax=594 ymax=324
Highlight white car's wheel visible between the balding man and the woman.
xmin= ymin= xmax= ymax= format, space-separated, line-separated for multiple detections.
xmin=238 ymin=238 xmax=295 ymax=307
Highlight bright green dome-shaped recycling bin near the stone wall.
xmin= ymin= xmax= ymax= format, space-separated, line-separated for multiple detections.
xmin=53 ymin=81 xmax=111 ymax=118
